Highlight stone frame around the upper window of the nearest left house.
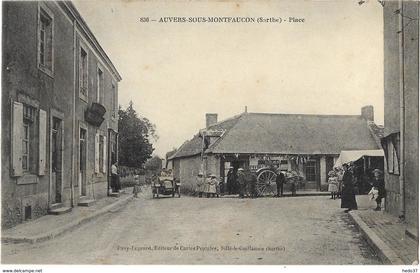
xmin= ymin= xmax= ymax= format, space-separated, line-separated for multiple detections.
xmin=37 ymin=2 xmax=54 ymax=77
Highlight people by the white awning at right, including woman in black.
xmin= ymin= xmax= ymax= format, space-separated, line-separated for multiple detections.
xmin=328 ymin=164 xmax=385 ymax=212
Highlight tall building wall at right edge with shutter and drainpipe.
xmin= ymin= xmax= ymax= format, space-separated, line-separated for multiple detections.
xmin=382 ymin=1 xmax=419 ymax=236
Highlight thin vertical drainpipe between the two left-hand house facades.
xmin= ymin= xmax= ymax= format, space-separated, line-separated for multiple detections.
xmin=70 ymin=19 xmax=77 ymax=207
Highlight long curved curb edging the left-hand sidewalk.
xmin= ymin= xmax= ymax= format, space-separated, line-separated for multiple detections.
xmin=1 ymin=195 xmax=133 ymax=244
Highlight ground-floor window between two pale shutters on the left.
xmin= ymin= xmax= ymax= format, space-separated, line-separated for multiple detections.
xmin=22 ymin=104 xmax=36 ymax=172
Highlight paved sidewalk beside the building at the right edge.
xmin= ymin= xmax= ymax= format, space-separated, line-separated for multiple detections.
xmin=349 ymin=195 xmax=418 ymax=265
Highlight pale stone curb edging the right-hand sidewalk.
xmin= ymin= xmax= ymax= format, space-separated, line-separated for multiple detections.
xmin=349 ymin=211 xmax=405 ymax=265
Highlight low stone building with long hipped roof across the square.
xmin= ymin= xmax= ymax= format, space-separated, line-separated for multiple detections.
xmin=169 ymin=106 xmax=381 ymax=193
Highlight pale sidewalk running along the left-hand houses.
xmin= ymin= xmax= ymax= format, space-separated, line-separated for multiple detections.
xmin=1 ymin=188 xmax=133 ymax=244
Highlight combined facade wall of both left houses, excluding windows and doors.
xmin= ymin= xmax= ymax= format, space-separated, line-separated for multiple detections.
xmin=1 ymin=1 xmax=118 ymax=228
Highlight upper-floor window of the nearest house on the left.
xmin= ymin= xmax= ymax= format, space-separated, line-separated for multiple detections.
xmin=38 ymin=7 xmax=53 ymax=75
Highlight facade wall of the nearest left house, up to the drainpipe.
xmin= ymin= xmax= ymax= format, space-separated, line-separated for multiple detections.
xmin=1 ymin=2 xmax=73 ymax=227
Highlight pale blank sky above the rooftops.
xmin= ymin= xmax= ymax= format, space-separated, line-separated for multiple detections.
xmin=74 ymin=0 xmax=384 ymax=156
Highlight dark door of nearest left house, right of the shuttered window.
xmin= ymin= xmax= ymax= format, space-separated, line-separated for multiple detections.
xmin=51 ymin=117 xmax=63 ymax=204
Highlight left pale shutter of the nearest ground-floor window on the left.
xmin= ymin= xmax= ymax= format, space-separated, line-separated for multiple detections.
xmin=11 ymin=101 xmax=23 ymax=176
